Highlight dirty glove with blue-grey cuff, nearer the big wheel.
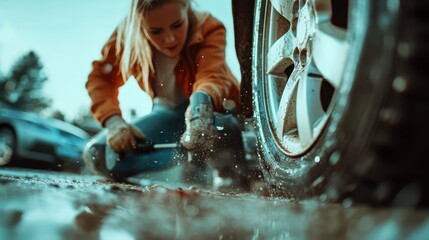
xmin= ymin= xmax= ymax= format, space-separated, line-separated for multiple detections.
xmin=180 ymin=91 xmax=220 ymax=153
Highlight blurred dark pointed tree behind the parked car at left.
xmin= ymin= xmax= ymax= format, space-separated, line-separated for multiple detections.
xmin=0 ymin=51 xmax=52 ymax=112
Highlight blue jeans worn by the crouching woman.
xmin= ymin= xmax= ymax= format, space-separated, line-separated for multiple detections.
xmin=83 ymin=103 xmax=188 ymax=180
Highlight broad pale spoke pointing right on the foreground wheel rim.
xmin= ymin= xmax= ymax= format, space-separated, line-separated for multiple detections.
xmin=312 ymin=22 xmax=349 ymax=88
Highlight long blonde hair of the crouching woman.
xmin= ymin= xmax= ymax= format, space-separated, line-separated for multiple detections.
xmin=115 ymin=0 xmax=195 ymax=90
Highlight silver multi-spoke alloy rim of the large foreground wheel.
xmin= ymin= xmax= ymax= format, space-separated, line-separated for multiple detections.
xmin=262 ymin=0 xmax=350 ymax=156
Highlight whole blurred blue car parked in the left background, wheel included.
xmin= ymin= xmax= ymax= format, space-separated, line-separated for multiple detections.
xmin=0 ymin=108 xmax=89 ymax=170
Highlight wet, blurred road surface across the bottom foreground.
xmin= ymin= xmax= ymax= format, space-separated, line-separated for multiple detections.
xmin=0 ymin=169 xmax=429 ymax=240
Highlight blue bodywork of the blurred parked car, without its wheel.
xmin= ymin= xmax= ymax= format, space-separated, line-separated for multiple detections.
xmin=0 ymin=108 xmax=89 ymax=168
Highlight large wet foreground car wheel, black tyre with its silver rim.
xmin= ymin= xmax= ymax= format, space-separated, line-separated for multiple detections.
xmin=252 ymin=0 xmax=429 ymax=206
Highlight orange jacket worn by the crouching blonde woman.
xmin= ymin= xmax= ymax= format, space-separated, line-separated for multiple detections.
xmin=86 ymin=15 xmax=240 ymax=126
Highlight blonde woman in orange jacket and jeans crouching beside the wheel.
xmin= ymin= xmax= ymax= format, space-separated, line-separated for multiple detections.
xmin=84 ymin=0 xmax=239 ymax=181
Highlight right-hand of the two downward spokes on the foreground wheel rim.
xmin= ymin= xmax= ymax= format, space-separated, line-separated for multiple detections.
xmin=296 ymin=76 xmax=325 ymax=147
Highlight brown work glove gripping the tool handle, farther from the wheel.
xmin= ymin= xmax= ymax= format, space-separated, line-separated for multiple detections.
xmin=106 ymin=115 xmax=145 ymax=152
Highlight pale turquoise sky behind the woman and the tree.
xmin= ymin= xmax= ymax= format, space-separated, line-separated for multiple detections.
xmin=0 ymin=0 xmax=240 ymax=121
